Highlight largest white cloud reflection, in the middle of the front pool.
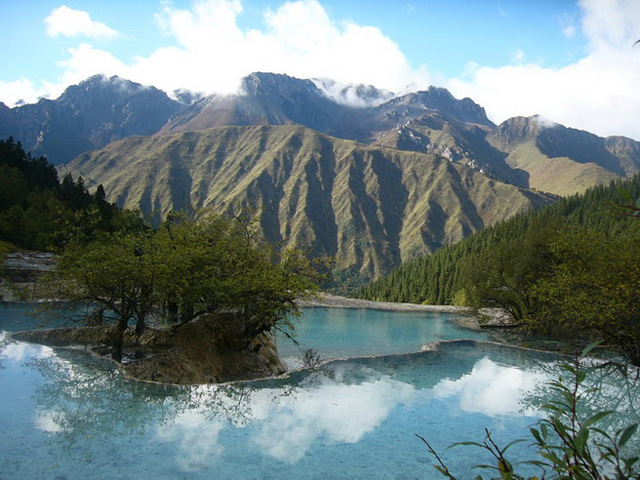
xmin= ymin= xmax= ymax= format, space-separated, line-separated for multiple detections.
xmin=158 ymin=372 xmax=416 ymax=471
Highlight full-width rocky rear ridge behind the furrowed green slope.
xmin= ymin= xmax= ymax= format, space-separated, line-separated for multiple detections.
xmin=0 ymin=72 xmax=640 ymax=195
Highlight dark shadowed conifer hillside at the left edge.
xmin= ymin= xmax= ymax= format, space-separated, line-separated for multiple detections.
xmin=0 ymin=138 xmax=140 ymax=251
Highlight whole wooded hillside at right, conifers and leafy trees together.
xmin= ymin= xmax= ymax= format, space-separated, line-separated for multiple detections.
xmin=359 ymin=176 xmax=640 ymax=365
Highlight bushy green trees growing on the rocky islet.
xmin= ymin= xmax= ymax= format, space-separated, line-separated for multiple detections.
xmin=49 ymin=214 xmax=317 ymax=359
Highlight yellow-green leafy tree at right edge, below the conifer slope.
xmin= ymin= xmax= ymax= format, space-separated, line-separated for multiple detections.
xmin=528 ymin=228 xmax=640 ymax=365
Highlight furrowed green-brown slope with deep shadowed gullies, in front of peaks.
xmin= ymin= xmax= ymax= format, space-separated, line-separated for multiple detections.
xmin=64 ymin=125 xmax=552 ymax=286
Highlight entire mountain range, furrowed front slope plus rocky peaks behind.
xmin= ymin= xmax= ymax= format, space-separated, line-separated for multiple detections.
xmin=0 ymin=73 xmax=640 ymax=282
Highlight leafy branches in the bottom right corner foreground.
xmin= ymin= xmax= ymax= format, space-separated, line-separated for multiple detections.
xmin=416 ymin=344 xmax=640 ymax=480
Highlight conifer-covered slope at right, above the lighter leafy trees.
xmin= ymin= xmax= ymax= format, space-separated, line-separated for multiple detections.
xmin=355 ymin=176 xmax=640 ymax=304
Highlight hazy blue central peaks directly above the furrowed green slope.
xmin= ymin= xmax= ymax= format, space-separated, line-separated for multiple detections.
xmin=160 ymin=72 xmax=493 ymax=143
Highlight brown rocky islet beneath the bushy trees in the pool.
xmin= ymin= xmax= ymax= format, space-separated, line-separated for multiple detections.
xmin=12 ymin=314 xmax=286 ymax=385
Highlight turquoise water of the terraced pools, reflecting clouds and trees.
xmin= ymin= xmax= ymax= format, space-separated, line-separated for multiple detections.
xmin=0 ymin=305 xmax=632 ymax=480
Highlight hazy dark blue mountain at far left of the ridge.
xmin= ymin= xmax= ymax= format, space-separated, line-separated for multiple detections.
xmin=0 ymin=75 xmax=183 ymax=165
